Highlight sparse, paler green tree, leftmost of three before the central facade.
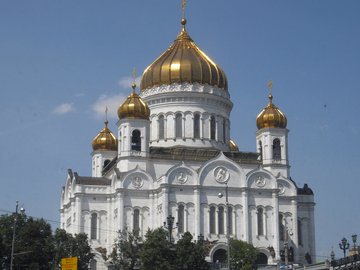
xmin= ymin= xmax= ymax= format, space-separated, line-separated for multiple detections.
xmin=110 ymin=230 xmax=142 ymax=270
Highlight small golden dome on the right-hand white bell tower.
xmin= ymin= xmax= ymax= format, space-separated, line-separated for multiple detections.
xmin=256 ymin=94 xmax=287 ymax=129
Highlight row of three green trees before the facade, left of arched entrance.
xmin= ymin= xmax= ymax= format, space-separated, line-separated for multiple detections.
xmin=110 ymin=228 xmax=208 ymax=270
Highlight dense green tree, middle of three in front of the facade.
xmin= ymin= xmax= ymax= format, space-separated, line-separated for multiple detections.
xmin=140 ymin=228 xmax=175 ymax=270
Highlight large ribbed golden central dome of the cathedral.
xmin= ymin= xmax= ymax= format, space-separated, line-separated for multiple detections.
xmin=140 ymin=19 xmax=228 ymax=91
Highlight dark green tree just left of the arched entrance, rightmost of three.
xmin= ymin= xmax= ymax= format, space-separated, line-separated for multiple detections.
xmin=175 ymin=232 xmax=209 ymax=270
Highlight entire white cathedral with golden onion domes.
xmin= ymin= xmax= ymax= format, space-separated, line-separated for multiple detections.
xmin=60 ymin=7 xmax=315 ymax=269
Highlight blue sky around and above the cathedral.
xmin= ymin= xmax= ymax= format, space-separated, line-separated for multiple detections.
xmin=0 ymin=0 xmax=360 ymax=260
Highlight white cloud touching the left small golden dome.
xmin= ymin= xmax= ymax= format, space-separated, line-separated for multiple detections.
xmin=92 ymin=94 xmax=126 ymax=118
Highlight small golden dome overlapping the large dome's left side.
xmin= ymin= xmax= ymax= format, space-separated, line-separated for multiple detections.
xmin=118 ymin=84 xmax=150 ymax=120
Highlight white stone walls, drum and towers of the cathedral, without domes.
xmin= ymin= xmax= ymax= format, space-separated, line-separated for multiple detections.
xmin=60 ymin=81 xmax=315 ymax=269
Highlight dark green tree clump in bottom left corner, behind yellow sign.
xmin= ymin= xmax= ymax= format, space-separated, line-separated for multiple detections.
xmin=0 ymin=214 xmax=93 ymax=270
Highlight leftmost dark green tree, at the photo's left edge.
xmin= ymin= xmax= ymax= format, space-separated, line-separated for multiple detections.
xmin=0 ymin=214 xmax=54 ymax=270
